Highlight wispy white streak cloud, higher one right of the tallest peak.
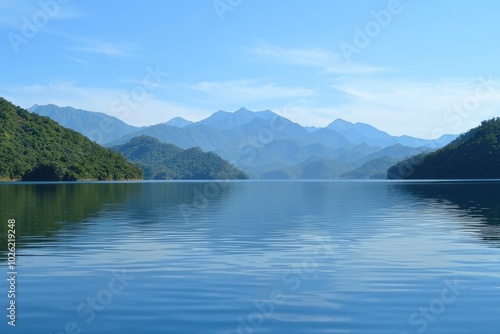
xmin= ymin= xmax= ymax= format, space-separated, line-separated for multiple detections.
xmin=247 ymin=42 xmax=387 ymax=75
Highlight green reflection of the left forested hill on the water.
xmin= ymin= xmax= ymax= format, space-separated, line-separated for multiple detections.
xmin=0 ymin=183 xmax=140 ymax=251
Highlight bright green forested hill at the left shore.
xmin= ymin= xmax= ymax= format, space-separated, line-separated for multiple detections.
xmin=0 ymin=98 xmax=142 ymax=181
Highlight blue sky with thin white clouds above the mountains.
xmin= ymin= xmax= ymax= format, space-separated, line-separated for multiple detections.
xmin=0 ymin=0 xmax=500 ymax=138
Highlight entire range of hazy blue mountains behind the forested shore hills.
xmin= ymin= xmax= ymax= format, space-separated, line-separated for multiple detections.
xmin=29 ymin=105 xmax=457 ymax=179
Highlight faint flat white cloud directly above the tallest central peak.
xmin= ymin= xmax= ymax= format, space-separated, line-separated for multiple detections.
xmin=190 ymin=80 xmax=314 ymax=102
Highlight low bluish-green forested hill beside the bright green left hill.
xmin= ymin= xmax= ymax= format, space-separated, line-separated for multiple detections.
xmin=111 ymin=136 xmax=248 ymax=180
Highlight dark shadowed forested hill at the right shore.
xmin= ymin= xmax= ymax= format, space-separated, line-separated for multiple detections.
xmin=387 ymin=117 xmax=500 ymax=179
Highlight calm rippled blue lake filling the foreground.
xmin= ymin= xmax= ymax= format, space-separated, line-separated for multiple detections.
xmin=0 ymin=181 xmax=500 ymax=334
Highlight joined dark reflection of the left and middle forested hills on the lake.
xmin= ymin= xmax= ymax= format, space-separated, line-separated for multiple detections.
xmin=0 ymin=182 xmax=234 ymax=254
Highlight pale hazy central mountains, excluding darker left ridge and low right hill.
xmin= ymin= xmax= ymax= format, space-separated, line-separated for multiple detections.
xmin=28 ymin=103 xmax=456 ymax=178
